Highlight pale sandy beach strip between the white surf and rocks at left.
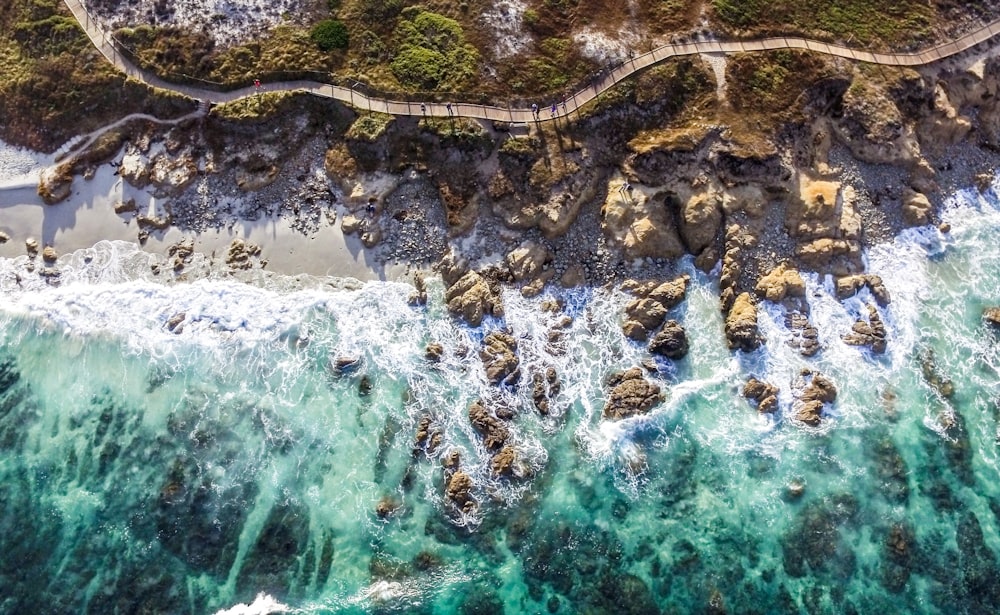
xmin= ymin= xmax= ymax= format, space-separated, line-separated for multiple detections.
xmin=0 ymin=143 xmax=405 ymax=281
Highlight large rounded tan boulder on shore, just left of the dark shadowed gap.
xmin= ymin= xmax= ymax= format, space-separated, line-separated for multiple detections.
xmin=601 ymin=181 xmax=684 ymax=259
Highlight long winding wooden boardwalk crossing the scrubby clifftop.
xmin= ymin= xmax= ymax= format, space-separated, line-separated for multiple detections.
xmin=64 ymin=0 xmax=1000 ymax=122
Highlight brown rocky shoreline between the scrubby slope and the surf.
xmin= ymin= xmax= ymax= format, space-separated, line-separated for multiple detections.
xmin=9 ymin=44 xmax=1000 ymax=356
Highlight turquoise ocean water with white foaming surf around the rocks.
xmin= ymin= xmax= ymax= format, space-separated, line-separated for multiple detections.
xmin=0 ymin=176 xmax=1000 ymax=613
